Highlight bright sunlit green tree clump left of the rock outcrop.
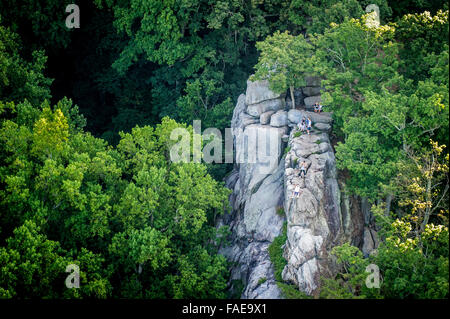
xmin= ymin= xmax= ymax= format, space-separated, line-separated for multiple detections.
xmin=0 ymin=99 xmax=229 ymax=298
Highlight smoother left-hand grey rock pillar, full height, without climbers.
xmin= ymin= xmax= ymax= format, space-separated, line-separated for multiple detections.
xmin=218 ymin=81 xmax=288 ymax=299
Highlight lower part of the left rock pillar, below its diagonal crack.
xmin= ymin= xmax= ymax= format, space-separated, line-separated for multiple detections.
xmin=219 ymin=162 xmax=284 ymax=299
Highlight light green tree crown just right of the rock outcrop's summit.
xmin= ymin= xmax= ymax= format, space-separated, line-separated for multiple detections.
xmin=312 ymin=15 xmax=400 ymax=133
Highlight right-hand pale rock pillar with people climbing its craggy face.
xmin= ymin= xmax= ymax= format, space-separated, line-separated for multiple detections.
xmin=282 ymin=123 xmax=341 ymax=295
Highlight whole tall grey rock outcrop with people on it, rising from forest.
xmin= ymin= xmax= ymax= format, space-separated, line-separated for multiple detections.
xmin=218 ymin=77 xmax=368 ymax=298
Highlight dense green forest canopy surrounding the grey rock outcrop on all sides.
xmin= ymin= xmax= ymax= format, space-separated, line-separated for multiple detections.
xmin=0 ymin=0 xmax=449 ymax=298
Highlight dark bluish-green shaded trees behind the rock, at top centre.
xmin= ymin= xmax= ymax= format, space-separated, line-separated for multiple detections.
xmin=91 ymin=0 xmax=298 ymax=135
